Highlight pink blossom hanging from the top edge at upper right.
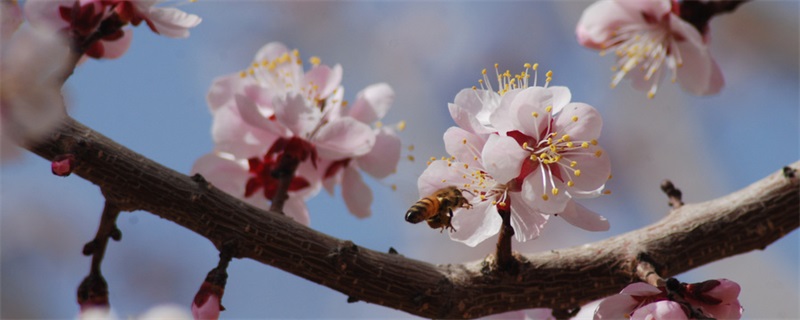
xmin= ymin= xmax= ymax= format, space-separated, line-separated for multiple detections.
xmin=576 ymin=0 xmax=724 ymax=98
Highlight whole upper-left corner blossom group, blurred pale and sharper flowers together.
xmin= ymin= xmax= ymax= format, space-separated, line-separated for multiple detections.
xmin=0 ymin=0 xmax=200 ymax=159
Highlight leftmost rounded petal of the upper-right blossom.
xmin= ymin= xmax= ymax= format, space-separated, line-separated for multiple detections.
xmin=575 ymin=0 xmax=643 ymax=50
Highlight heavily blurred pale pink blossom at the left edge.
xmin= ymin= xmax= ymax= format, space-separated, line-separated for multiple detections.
xmin=0 ymin=22 xmax=69 ymax=161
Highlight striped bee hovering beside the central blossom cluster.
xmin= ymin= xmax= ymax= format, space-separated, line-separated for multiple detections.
xmin=406 ymin=186 xmax=472 ymax=232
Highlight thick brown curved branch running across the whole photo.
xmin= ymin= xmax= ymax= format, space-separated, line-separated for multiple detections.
xmin=29 ymin=118 xmax=800 ymax=318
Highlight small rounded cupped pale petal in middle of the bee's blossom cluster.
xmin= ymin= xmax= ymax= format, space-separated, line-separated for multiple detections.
xmin=481 ymin=134 xmax=529 ymax=184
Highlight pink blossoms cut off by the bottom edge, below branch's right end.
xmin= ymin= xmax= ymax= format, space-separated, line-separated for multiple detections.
xmin=594 ymin=279 xmax=743 ymax=320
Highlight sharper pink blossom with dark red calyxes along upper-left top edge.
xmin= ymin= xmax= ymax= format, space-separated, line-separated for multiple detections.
xmin=25 ymin=0 xmax=202 ymax=59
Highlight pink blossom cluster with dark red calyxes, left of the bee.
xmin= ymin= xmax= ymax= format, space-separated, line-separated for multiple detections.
xmin=192 ymin=42 xmax=402 ymax=224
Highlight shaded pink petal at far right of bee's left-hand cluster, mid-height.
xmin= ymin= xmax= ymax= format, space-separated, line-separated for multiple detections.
xmin=356 ymin=127 xmax=402 ymax=179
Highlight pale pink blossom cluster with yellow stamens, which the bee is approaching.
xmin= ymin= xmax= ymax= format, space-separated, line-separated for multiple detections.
xmin=418 ymin=64 xmax=611 ymax=246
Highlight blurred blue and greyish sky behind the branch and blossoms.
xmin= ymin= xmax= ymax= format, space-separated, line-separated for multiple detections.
xmin=0 ymin=0 xmax=800 ymax=319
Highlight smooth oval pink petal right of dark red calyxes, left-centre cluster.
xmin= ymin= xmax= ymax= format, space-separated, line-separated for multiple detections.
xmin=312 ymin=117 xmax=375 ymax=160
